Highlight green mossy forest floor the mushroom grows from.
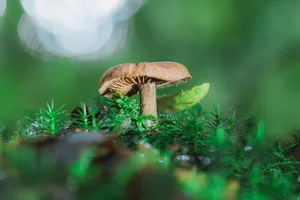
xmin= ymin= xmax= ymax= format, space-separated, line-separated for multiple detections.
xmin=0 ymin=91 xmax=300 ymax=200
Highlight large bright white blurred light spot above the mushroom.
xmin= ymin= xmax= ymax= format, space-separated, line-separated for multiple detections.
xmin=18 ymin=0 xmax=145 ymax=60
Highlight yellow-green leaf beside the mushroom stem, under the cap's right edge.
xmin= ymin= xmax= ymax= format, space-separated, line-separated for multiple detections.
xmin=157 ymin=83 xmax=210 ymax=111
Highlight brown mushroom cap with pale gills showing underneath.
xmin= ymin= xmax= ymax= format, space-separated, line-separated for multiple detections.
xmin=99 ymin=62 xmax=192 ymax=98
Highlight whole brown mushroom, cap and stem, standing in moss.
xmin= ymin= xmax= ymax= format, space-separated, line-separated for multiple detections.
xmin=98 ymin=62 xmax=192 ymax=116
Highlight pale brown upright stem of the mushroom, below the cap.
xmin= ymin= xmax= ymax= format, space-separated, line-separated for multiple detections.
xmin=138 ymin=83 xmax=157 ymax=117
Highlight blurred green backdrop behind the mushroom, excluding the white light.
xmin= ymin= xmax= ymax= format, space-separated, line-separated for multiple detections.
xmin=0 ymin=0 xmax=300 ymax=136
